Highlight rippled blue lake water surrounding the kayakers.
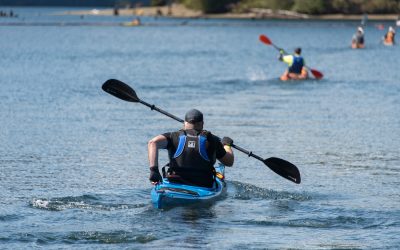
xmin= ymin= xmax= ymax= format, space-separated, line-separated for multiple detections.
xmin=0 ymin=8 xmax=400 ymax=249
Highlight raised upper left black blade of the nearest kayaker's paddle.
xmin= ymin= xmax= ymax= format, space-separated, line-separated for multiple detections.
xmin=101 ymin=79 xmax=140 ymax=102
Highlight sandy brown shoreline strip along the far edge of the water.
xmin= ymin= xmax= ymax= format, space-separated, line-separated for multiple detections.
xmin=56 ymin=4 xmax=399 ymax=21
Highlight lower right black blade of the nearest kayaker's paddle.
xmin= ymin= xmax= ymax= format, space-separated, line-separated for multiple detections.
xmin=263 ymin=157 xmax=301 ymax=184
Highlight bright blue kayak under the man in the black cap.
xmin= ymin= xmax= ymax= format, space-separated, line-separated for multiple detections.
xmin=151 ymin=164 xmax=226 ymax=208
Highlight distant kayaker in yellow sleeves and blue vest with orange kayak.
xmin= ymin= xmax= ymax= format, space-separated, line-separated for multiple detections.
xmin=279 ymin=48 xmax=308 ymax=81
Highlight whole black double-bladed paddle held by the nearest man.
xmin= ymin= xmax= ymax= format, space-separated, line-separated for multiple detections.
xmin=102 ymin=79 xmax=301 ymax=184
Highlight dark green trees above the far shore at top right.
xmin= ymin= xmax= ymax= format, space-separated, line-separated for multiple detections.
xmin=152 ymin=0 xmax=400 ymax=15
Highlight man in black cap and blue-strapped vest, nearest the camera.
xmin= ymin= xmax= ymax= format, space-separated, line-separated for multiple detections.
xmin=148 ymin=109 xmax=234 ymax=187
